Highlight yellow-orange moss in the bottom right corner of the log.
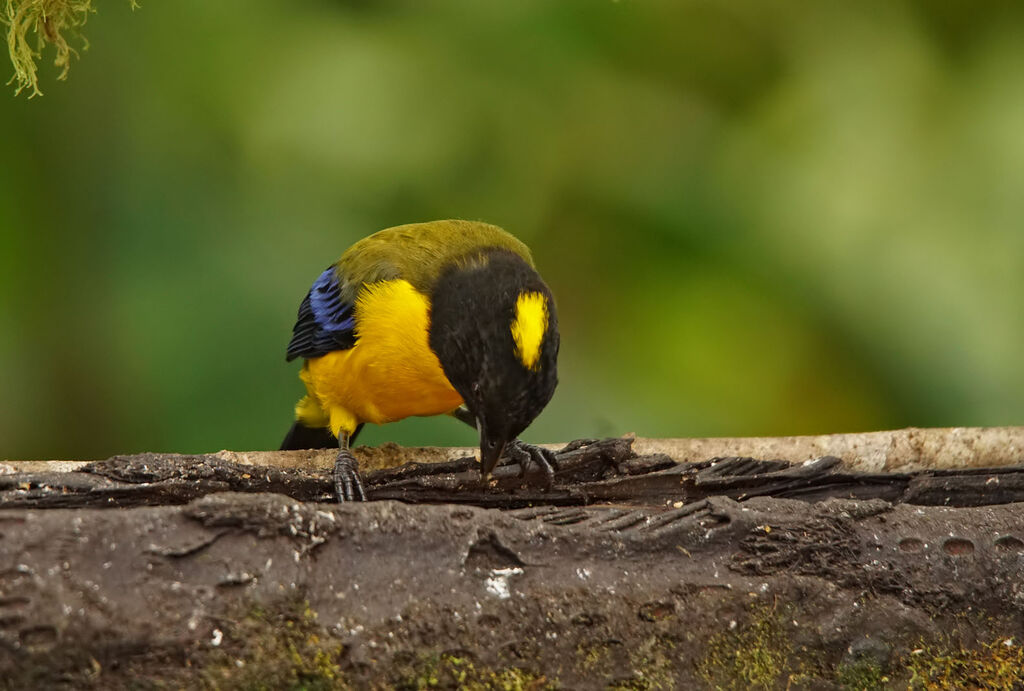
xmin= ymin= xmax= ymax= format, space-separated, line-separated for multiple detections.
xmin=903 ymin=638 xmax=1024 ymax=691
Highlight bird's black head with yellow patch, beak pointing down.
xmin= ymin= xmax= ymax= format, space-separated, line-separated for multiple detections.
xmin=430 ymin=250 xmax=558 ymax=477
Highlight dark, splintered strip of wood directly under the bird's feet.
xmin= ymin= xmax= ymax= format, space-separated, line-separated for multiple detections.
xmin=0 ymin=439 xmax=1024 ymax=509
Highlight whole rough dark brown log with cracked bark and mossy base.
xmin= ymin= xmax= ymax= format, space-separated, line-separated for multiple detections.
xmin=0 ymin=429 xmax=1024 ymax=689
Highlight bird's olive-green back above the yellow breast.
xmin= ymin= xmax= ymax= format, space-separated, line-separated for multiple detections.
xmin=337 ymin=220 xmax=534 ymax=303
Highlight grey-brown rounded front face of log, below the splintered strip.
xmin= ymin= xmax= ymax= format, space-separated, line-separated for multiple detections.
xmin=0 ymin=491 xmax=1024 ymax=690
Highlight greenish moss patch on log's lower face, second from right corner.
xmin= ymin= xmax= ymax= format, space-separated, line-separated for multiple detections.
xmin=697 ymin=604 xmax=793 ymax=689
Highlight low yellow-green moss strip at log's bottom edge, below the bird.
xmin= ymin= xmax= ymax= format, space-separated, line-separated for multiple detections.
xmin=395 ymin=653 xmax=558 ymax=691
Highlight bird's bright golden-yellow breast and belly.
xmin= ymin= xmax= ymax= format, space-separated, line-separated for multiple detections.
xmin=298 ymin=279 xmax=462 ymax=435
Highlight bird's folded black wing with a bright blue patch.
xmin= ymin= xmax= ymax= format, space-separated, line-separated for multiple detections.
xmin=285 ymin=266 xmax=355 ymax=361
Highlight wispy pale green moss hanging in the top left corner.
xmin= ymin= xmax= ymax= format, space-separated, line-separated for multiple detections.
xmin=3 ymin=0 xmax=138 ymax=96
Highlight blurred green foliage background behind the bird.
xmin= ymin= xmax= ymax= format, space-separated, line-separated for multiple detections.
xmin=0 ymin=0 xmax=1024 ymax=459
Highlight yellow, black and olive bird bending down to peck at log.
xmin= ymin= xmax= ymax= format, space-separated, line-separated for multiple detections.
xmin=282 ymin=219 xmax=560 ymax=502
